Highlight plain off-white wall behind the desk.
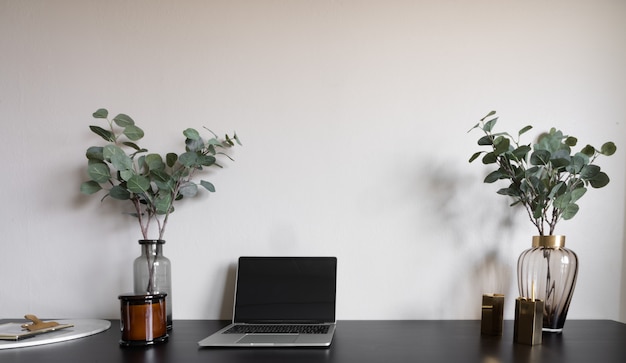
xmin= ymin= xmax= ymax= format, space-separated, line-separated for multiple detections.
xmin=0 ymin=0 xmax=626 ymax=321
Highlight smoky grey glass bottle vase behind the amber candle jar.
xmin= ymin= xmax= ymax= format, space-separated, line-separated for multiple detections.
xmin=133 ymin=239 xmax=172 ymax=330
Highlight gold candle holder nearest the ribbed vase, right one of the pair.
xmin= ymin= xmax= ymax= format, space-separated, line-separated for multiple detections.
xmin=513 ymin=297 xmax=543 ymax=345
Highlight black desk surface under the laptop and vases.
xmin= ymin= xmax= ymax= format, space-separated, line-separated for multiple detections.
xmin=0 ymin=320 xmax=626 ymax=363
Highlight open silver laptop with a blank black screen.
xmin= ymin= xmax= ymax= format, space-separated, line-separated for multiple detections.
xmin=198 ymin=257 xmax=337 ymax=347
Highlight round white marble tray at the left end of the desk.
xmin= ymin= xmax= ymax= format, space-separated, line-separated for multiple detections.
xmin=0 ymin=319 xmax=111 ymax=349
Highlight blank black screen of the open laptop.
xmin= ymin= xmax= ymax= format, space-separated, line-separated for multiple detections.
xmin=233 ymin=257 xmax=337 ymax=323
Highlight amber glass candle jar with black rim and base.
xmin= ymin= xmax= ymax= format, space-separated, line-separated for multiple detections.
xmin=119 ymin=294 xmax=168 ymax=346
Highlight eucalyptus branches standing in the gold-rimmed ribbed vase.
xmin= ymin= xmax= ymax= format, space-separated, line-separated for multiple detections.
xmin=469 ymin=111 xmax=616 ymax=236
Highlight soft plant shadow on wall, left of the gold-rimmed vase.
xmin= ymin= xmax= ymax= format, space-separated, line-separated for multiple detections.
xmin=417 ymin=160 xmax=523 ymax=318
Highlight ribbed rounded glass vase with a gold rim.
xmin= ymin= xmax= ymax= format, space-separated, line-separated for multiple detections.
xmin=517 ymin=235 xmax=578 ymax=333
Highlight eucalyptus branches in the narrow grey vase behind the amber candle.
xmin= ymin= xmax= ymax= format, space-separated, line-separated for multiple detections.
xmin=80 ymin=108 xmax=241 ymax=239
